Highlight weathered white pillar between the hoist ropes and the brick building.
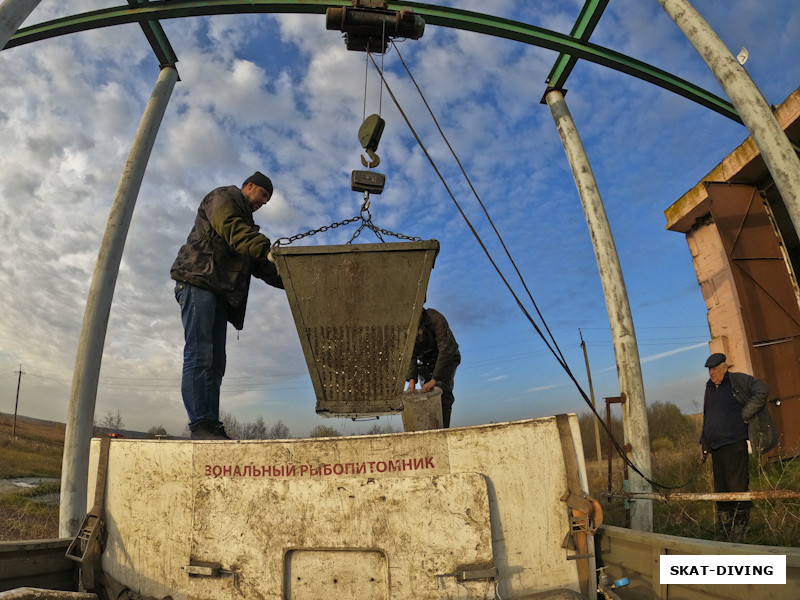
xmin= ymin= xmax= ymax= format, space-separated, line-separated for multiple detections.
xmin=545 ymin=90 xmax=653 ymax=531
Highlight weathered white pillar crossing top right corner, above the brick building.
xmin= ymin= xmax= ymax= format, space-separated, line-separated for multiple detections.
xmin=658 ymin=0 xmax=800 ymax=232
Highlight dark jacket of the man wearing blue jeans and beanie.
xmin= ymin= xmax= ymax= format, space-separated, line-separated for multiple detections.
xmin=170 ymin=185 xmax=283 ymax=329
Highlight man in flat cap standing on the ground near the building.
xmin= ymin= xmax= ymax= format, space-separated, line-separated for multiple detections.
xmin=700 ymin=353 xmax=777 ymax=542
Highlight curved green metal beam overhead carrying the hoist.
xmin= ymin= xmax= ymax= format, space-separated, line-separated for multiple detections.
xmin=6 ymin=0 xmax=741 ymax=123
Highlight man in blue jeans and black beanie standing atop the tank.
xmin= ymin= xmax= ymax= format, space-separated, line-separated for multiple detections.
xmin=170 ymin=171 xmax=283 ymax=440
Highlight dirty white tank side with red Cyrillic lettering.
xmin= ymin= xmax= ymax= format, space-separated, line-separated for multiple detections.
xmin=89 ymin=415 xmax=594 ymax=600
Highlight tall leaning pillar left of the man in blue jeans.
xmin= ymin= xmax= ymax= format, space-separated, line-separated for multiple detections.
xmin=59 ymin=66 xmax=178 ymax=537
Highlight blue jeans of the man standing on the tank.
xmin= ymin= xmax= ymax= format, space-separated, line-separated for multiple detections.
xmin=175 ymin=282 xmax=228 ymax=431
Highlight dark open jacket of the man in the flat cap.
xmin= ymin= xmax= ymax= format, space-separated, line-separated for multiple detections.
xmin=700 ymin=371 xmax=778 ymax=456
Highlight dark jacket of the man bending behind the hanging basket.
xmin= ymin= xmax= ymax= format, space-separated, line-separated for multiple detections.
xmin=406 ymin=308 xmax=461 ymax=381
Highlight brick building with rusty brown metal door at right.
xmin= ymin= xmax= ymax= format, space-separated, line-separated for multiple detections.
xmin=664 ymin=89 xmax=800 ymax=458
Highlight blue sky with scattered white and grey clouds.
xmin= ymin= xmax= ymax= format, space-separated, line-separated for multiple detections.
xmin=0 ymin=0 xmax=800 ymax=436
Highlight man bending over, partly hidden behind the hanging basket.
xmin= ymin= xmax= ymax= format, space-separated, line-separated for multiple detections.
xmin=406 ymin=308 xmax=461 ymax=427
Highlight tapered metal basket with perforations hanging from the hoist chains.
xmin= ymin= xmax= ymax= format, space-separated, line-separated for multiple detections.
xmin=272 ymin=240 xmax=439 ymax=417
